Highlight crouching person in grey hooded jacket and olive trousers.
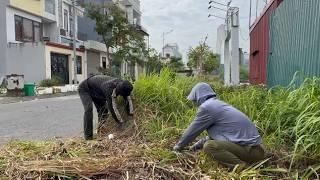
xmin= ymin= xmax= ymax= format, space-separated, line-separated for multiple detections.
xmin=174 ymin=83 xmax=265 ymax=168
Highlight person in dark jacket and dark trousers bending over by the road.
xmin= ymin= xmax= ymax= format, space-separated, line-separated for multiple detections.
xmin=79 ymin=75 xmax=133 ymax=140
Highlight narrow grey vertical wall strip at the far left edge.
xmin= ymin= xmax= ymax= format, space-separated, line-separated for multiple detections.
xmin=0 ymin=0 xmax=9 ymax=79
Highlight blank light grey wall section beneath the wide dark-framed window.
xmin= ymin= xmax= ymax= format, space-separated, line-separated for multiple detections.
xmin=7 ymin=43 xmax=46 ymax=83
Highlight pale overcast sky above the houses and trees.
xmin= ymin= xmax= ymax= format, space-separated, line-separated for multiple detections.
xmin=141 ymin=0 xmax=265 ymax=61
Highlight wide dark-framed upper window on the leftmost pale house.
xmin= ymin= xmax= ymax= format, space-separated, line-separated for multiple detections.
xmin=14 ymin=15 xmax=41 ymax=42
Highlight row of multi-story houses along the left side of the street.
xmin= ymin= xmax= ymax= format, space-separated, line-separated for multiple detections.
xmin=0 ymin=0 xmax=149 ymax=84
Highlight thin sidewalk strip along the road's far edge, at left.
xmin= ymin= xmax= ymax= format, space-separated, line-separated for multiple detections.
xmin=0 ymin=92 xmax=78 ymax=104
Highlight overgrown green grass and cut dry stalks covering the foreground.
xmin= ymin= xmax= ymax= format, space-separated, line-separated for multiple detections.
xmin=0 ymin=70 xmax=320 ymax=179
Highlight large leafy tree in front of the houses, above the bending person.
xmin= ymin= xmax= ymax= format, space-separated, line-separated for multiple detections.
xmin=86 ymin=3 xmax=147 ymax=71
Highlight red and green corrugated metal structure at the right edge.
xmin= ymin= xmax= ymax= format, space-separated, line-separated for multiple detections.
xmin=250 ymin=0 xmax=320 ymax=87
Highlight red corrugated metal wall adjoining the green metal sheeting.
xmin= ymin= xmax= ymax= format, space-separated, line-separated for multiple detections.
xmin=250 ymin=0 xmax=283 ymax=84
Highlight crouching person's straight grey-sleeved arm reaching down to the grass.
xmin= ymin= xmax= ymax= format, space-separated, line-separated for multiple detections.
xmin=174 ymin=106 xmax=214 ymax=151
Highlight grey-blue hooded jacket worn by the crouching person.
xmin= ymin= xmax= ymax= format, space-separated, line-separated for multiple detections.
xmin=176 ymin=83 xmax=262 ymax=149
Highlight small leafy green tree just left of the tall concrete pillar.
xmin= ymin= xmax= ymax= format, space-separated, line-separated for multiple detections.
xmin=187 ymin=43 xmax=219 ymax=74
